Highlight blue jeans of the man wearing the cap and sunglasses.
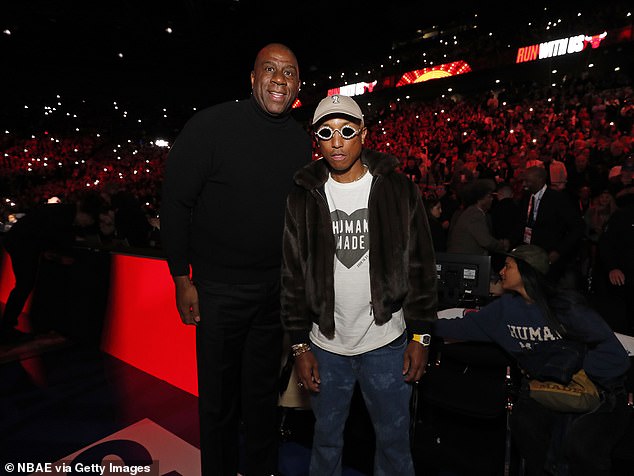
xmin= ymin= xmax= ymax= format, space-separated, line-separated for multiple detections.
xmin=310 ymin=334 xmax=414 ymax=476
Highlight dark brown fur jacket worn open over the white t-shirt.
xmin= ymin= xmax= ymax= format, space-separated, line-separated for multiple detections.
xmin=282 ymin=150 xmax=437 ymax=344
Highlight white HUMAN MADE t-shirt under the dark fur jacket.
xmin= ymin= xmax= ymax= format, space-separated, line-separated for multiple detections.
xmin=310 ymin=169 xmax=405 ymax=355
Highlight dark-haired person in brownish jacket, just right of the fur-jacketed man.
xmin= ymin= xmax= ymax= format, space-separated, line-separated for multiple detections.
xmin=447 ymin=179 xmax=509 ymax=255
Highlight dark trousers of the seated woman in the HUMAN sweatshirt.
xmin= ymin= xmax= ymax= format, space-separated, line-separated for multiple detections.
xmin=511 ymin=390 xmax=630 ymax=476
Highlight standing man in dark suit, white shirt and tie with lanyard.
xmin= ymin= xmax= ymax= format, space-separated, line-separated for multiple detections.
xmin=522 ymin=166 xmax=585 ymax=284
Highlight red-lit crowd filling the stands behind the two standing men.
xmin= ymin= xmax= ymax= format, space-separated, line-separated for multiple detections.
xmin=0 ymin=72 xmax=634 ymax=251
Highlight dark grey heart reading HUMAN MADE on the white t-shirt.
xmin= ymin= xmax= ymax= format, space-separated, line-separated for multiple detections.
xmin=330 ymin=208 xmax=370 ymax=269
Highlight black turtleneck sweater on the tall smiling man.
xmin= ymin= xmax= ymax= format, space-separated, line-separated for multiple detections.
xmin=161 ymin=97 xmax=311 ymax=284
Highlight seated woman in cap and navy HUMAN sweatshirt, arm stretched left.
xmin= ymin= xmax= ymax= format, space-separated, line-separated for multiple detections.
xmin=436 ymin=245 xmax=630 ymax=476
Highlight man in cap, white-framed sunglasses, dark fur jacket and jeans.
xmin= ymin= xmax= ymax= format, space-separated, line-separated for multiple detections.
xmin=282 ymin=95 xmax=437 ymax=476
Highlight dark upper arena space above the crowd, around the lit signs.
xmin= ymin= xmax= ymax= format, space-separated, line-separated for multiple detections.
xmin=0 ymin=0 xmax=632 ymax=137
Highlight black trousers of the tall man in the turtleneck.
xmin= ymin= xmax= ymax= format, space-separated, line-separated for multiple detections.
xmin=196 ymin=281 xmax=282 ymax=476
